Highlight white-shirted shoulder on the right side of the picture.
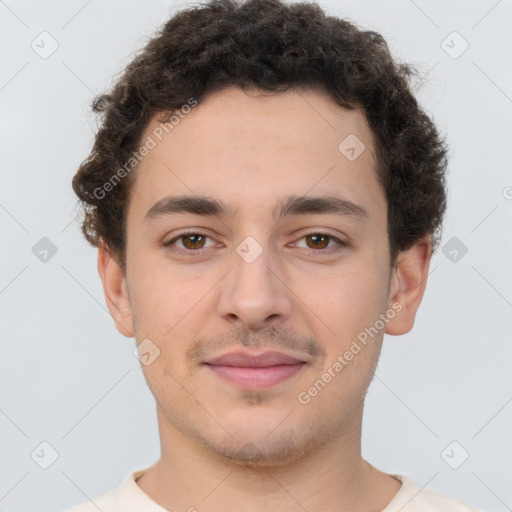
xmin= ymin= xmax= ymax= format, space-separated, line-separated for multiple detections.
xmin=388 ymin=475 xmax=482 ymax=512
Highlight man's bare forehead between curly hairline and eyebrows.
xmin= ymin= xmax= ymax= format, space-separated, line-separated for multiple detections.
xmin=129 ymin=88 xmax=386 ymax=224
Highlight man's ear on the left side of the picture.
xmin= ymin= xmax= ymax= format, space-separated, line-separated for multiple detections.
xmin=98 ymin=239 xmax=135 ymax=338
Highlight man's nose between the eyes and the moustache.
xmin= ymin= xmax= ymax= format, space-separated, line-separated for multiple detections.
xmin=218 ymin=238 xmax=292 ymax=330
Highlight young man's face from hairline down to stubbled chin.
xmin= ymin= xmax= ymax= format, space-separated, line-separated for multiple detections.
xmin=100 ymin=88 xmax=421 ymax=466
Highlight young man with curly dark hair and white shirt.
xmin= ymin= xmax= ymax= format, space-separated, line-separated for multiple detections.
xmin=67 ymin=0 xmax=475 ymax=512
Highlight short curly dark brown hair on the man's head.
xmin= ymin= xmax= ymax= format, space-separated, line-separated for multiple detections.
xmin=73 ymin=0 xmax=448 ymax=270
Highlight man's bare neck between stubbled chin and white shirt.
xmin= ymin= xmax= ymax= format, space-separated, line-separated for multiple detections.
xmin=137 ymin=407 xmax=400 ymax=512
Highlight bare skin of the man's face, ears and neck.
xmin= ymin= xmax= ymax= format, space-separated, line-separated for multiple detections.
xmin=98 ymin=88 xmax=431 ymax=512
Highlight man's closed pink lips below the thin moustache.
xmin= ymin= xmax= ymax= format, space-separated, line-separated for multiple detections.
xmin=204 ymin=351 xmax=307 ymax=391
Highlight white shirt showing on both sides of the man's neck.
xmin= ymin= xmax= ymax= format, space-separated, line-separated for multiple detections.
xmin=65 ymin=469 xmax=480 ymax=512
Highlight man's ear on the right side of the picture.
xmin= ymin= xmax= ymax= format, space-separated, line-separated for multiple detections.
xmin=385 ymin=236 xmax=432 ymax=336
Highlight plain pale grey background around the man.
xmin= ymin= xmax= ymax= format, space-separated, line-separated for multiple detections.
xmin=0 ymin=0 xmax=512 ymax=512
